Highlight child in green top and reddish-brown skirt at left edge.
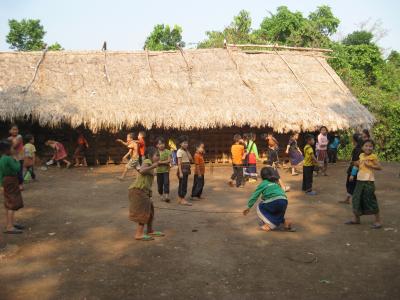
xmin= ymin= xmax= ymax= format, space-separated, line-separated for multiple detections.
xmin=0 ymin=140 xmax=24 ymax=234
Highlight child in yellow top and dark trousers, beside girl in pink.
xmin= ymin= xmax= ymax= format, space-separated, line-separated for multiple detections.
xmin=303 ymin=135 xmax=318 ymax=196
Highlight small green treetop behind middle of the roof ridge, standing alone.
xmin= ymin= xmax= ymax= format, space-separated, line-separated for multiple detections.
xmin=144 ymin=24 xmax=185 ymax=51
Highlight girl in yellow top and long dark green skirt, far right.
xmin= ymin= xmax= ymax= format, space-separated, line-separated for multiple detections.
xmin=346 ymin=140 xmax=382 ymax=229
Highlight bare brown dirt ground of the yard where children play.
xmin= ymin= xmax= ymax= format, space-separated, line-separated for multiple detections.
xmin=0 ymin=162 xmax=400 ymax=299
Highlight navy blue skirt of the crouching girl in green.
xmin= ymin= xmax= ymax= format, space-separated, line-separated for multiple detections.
xmin=257 ymin=199 xmax=287 ymax=229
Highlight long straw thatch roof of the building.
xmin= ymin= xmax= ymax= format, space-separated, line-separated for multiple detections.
xmin=0 ymin=49 xmax=374 ymax=132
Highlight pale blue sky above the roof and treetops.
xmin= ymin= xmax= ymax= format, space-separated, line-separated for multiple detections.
xmin=0 ymin=0 xmax=400 ymax=53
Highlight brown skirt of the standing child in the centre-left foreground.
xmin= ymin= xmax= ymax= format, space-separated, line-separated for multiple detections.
xmin=129 ymin=188 xmax=154 ymax=224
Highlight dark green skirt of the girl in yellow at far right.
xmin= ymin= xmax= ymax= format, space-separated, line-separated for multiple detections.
xmin=352 ymin=180 xmax=379 ymax=216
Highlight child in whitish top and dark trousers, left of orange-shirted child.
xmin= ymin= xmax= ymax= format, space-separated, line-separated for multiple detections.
xmin=176 ymin=136 xmax=193 ymax=206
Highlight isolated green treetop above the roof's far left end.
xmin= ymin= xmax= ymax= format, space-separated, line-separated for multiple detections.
xmin=6 ymin=19 xmax=46 ymax=51
